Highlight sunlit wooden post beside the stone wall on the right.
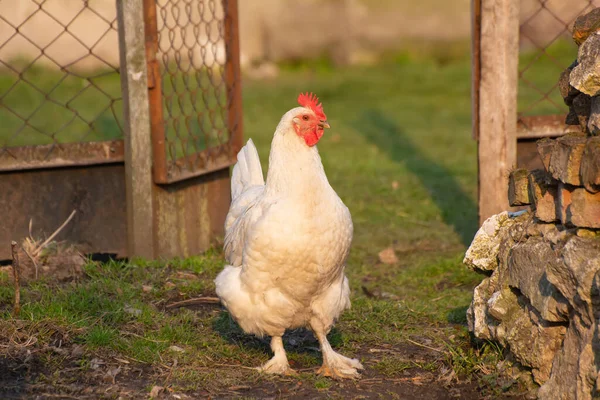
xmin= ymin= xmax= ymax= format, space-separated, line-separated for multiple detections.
xmin=474 ymin=0 xmax=519 ymax=224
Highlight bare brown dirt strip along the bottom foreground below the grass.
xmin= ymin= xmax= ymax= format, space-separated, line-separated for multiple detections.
xmin=0 ymin=305 xmax=526 ymax=400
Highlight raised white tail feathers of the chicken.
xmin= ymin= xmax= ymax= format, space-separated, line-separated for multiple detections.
xmin=231 ymin=139 xmax=265 ymax=199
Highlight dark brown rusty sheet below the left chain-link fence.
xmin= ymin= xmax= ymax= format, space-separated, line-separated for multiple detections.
xmin=0 ymin=164 xmax=127 ymax=260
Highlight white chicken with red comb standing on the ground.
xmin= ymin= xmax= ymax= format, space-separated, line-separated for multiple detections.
xmin=215 ymin=94 xmax=363 ymax=378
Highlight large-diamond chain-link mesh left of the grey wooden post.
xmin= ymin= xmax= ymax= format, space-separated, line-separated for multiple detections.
xmin=0 ymin=0 xmax=122 ymax=156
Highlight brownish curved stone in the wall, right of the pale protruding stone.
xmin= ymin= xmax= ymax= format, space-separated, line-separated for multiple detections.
xmin=508 ymin=237 xmax=568 ymax=322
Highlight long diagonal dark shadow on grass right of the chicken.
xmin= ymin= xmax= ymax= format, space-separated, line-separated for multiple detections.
xmin=357 ymin=110 xmax=477 ymax=245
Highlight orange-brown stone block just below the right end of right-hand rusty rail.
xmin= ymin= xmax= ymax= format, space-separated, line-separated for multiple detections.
xmin=548 ymin=135 xmax=586 ymax=186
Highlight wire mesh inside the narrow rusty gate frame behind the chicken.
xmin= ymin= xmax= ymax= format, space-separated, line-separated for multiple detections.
xmin=156 ymin=0 xmax=232 ymax=179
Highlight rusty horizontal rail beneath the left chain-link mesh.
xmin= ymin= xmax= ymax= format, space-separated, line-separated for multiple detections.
xmin=0 ymin=140 xmax=123 ymax=171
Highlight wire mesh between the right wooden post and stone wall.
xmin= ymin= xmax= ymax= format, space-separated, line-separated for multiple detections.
xmin=518 ymin=0 xmax=600 ymax=120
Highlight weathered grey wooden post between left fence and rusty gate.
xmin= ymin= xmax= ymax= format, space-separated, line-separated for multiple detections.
xmin=117 ymin=0 xmax=155 ymax=258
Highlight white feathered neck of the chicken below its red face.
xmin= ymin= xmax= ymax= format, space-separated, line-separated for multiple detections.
xmin=266 ymin=131 xmax=330 ymax=196
